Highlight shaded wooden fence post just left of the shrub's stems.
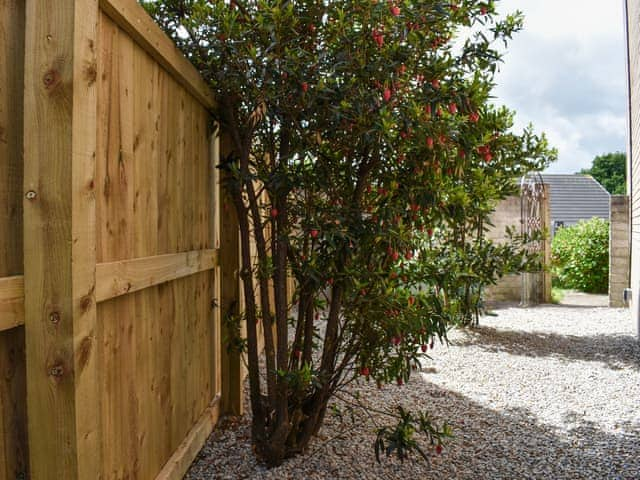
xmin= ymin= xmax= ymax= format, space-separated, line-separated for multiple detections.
xmin=220 ymin=136 xmax=243 ymax=415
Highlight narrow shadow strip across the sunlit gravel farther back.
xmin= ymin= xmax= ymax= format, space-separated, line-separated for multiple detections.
xmin=452 ymin=326 xmax=640 ymax=370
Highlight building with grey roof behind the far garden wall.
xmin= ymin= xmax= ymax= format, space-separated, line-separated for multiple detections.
xmin=542 ymin=173 xmax=610 ymax=236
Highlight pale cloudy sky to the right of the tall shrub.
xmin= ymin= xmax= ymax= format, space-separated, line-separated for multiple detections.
xmin=494 ymin=0 xmax=627 ymax=173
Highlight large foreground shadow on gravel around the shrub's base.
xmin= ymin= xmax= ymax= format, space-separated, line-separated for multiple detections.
xmin=185 ymin=374 xmax=640 ymax=480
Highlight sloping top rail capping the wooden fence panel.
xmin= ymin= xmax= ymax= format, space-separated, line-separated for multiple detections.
xmin=100 ymin=0 xmax=215 ymax=109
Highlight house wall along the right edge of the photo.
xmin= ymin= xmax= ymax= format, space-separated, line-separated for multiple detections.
xmin=625 ymin=0 xmax=640 ymax=335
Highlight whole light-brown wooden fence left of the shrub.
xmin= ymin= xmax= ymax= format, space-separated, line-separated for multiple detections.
xmin=0 ymin=0 xmax=241 ymax=480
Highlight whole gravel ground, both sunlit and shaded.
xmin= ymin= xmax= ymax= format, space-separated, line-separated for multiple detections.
xmin=185 ymin=306 xmax=640 ymax=480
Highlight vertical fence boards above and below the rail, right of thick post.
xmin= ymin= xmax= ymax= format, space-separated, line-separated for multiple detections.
xmin=96 ymin=14 xmax=220 ymax=479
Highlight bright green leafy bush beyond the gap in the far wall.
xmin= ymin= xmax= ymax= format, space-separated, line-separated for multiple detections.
xmin=551 ymin=217 xmax=609 ymax=293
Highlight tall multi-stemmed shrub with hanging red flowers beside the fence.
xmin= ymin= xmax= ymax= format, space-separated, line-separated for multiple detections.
xmin=143 ymin=0 xmax=553 ymax=465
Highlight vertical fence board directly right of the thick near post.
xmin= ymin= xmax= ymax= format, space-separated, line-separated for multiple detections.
xmin=97 ymin=15 xmax=139 ymax=478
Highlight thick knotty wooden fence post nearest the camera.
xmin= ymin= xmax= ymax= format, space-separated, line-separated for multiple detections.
xmin=23 ymin=0 xmax=100 ymax=480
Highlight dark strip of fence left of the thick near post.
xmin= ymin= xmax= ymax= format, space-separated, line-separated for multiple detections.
xmin=0 ymin=0 xmax=28 ymax=479
